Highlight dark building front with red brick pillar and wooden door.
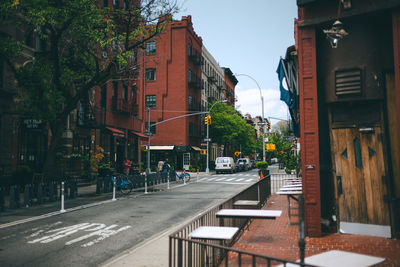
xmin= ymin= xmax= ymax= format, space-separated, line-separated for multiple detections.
xmin=295 ymin=0 xmax=400 ymax=237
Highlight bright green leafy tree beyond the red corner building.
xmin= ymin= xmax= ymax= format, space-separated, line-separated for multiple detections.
xmin=210 ymin=103 xmax=255 ymax=155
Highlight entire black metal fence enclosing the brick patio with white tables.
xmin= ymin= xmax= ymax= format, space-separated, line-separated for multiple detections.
xmin=169 ymin=174 xmax=306 ymax=267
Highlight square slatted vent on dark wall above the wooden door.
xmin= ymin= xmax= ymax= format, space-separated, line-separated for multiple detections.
xmin=335 ymin=69 xmax=362 ymax=96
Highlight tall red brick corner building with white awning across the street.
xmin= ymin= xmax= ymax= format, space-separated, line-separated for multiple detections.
xmin=138 ymin=16 xmax=202 ymax=169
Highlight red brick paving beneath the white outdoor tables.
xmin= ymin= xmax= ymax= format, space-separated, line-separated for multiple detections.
xmin=234 ymin=195 xmax=400 ymax=266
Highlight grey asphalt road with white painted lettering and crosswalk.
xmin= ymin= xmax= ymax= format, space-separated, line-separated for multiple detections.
xmin=0 ymin=170 xmax=258 ymax=266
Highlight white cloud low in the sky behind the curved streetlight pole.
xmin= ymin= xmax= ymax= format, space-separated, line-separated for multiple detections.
xmin=235 ymin=86 xmax=288 ymax=123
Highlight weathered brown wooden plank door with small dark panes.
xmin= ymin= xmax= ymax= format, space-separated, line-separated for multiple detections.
xmin=332 ymin=127 xmax=390 ymax=231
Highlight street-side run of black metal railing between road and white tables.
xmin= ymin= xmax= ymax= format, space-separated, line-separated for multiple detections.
xmin=169 ymin=175 xmax=271 ymax=267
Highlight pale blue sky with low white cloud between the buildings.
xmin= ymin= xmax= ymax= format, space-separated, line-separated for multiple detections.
xmin=174 ymin=0 xmax=297 ymax=124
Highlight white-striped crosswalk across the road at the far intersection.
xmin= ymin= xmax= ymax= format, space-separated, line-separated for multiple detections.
xmin=199 ymin=172 xmax=258 ymax=184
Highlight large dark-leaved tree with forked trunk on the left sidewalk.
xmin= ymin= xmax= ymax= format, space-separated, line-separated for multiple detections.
xmin=0 ymin=0 xmax=177 ymax=179
